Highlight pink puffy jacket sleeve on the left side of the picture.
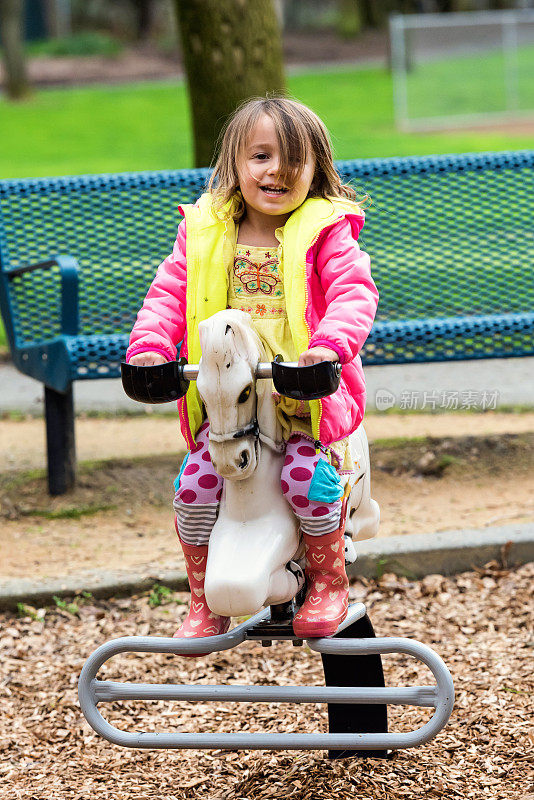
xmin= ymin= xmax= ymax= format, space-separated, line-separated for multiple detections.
xmin=126 ymin=219 xmax=187 ymax=361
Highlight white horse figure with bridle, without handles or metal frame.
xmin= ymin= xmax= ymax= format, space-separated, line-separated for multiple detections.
xmin=197 ymin=310 xmax=380 ymax=617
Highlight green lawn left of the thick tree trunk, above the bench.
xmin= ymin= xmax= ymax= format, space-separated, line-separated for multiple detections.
xmin=0 ymin=84 xmax=192 ymax=178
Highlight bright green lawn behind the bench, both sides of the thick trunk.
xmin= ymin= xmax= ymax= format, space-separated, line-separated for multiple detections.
xmin=0 ymin=64 xmax=532 ymax=178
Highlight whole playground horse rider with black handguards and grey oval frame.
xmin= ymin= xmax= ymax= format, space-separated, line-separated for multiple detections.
xmin=79 ymin=311 xmax=454 ymax=758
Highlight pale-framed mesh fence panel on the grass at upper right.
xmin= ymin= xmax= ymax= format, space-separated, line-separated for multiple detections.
xmin=390 ymin=10 xmax=534 ymax=130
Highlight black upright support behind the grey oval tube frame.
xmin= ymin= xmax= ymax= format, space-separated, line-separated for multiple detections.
xmin=321 ymin=614 xmax=390 ymax=759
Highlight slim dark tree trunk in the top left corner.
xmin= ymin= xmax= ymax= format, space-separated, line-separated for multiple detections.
xmin=0 ymin=0 xmax=29 ymax=100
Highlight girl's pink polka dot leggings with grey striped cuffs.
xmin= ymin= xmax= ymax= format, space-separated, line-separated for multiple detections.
xmin=174 ymin=421 xmax=341 ymax=546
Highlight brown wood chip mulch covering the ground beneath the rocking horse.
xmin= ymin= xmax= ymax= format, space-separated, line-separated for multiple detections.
xmin=0 ymin=563 xmax=534 ymax=800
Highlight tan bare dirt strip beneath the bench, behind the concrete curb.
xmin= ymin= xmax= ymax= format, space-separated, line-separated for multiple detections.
xmin=0 ymin=412 xmax=534 ymax=577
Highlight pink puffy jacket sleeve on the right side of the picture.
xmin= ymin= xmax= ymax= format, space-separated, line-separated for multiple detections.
xmin=309 ymin=217 xmax=378 ymax=364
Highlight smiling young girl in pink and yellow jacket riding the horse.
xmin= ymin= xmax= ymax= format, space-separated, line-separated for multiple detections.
xmin=127 ymin=97 xmax=378 ymax=638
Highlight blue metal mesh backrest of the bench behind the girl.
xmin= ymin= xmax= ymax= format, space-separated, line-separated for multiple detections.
xmin=0 ymin=151 xmax=534 ymax=345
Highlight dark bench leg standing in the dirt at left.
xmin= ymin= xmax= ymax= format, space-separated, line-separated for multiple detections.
xmin=45 ymin=383 xmax=76 ymax=495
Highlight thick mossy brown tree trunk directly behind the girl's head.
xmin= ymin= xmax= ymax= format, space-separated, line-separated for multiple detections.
xmin=174 ymin=0 xmax=286 ymax=167
